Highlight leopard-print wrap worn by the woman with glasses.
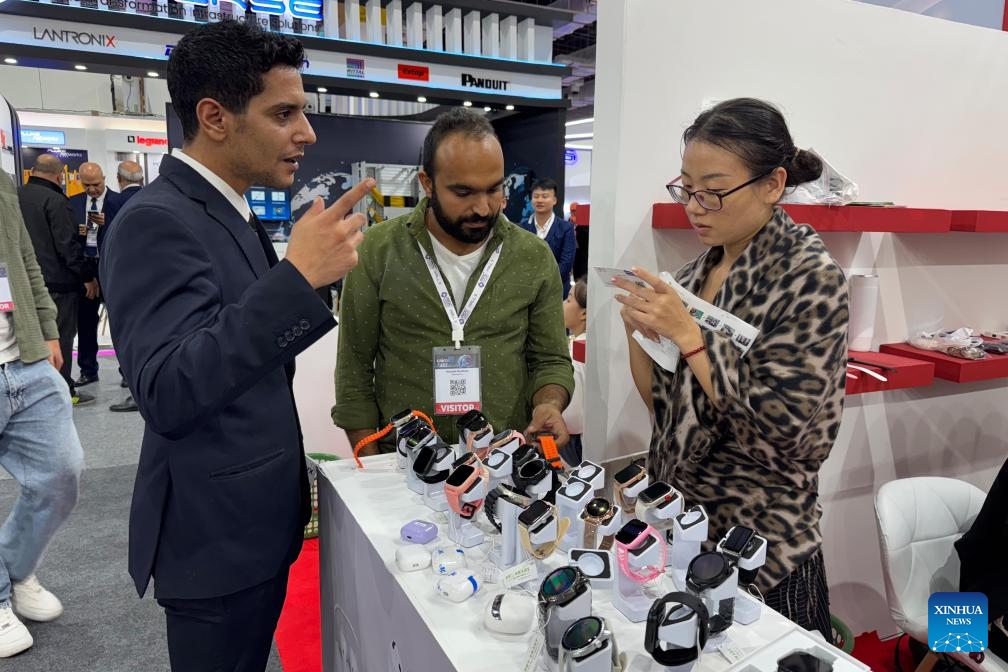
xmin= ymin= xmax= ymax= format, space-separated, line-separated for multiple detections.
xmin=648 ymin=208 xmax=848 ymax=591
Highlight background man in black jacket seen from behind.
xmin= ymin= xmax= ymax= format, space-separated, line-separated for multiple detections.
xmin=18 ymin=154 xmax=98 ymax=406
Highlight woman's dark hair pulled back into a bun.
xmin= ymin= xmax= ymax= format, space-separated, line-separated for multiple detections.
xmin=682 ymin=98 xmax=823 ymax=186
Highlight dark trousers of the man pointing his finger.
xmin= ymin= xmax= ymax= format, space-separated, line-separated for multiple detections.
xmin=155 ymin=567 xmax=289 ymax=672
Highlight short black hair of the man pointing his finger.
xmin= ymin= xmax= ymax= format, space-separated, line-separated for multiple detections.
xmin=168 ymin=19 xmax=304 ymax=142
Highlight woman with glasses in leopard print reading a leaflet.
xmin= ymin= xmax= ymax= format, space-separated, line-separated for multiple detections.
xmin=618 ymin=99 xmax=848 ymax=635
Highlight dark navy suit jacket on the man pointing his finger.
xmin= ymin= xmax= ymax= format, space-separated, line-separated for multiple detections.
xmin=100 ymin=156 xmax=336 ymax=598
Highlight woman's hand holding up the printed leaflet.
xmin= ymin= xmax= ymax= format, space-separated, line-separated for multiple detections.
xmin=613 ymin=267 xmax=702 ymax=350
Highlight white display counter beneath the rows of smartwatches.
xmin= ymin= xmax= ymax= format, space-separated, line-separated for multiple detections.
xmin=319 ymin=455 xmax=867 ymax=672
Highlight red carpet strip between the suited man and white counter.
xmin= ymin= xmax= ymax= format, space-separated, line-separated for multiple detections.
xmin=275 ymin=539 xmax=322 ymax=672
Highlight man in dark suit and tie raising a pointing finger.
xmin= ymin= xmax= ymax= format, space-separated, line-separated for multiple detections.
xmin=101 ymin=20 xmax=374 ymax=672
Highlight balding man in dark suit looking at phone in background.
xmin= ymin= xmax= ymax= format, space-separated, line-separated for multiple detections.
xmin=70 ymin=161 xmax=119 ymax=387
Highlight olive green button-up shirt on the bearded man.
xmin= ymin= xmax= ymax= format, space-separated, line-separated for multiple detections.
xmin=333 ymin=198 xmax=574 ymax=442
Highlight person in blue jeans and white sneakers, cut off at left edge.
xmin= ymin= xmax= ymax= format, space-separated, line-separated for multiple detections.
xmin=0 ymin=171 xmax=84 ymax=658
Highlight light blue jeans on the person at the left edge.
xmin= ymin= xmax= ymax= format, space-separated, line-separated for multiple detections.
xmin=0 ymin=360 xmax=84 ymax=602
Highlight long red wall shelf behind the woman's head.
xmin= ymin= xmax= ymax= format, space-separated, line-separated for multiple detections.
xmin=651 ymin=203 xmax=951 ymax=234
